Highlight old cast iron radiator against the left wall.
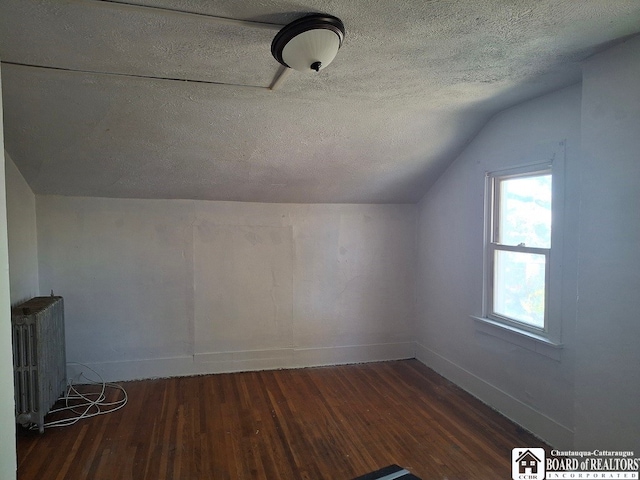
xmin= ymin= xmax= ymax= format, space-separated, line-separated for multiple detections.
xmin=11 ymin=296 xmax=67 ymax=433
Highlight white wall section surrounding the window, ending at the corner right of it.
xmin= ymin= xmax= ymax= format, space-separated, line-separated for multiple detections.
xmin=417 ymin=85 xmax=581 ymax=447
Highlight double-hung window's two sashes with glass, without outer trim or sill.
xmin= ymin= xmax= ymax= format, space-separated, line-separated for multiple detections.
xmin=484 ymin=165 xmax=552 ymax=334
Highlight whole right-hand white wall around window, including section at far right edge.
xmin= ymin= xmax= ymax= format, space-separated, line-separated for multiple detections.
xmin=417 ymin=37 xmax=640 ymax=453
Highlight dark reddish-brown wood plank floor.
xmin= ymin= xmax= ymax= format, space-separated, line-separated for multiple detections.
xmin=17 ymin=360 xmax=549 ymax=480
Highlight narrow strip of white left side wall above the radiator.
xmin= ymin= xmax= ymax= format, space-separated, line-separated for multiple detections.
xmin=5 ymin=152 xmax=38 ymax=305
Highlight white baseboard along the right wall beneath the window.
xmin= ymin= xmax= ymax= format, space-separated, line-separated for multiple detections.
xmin=415 ymin=342 xmax=574 ymax=449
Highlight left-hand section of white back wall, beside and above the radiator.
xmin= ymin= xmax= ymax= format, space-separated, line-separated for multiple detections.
xmin=36 ymin=196 xmax=193 ymax=363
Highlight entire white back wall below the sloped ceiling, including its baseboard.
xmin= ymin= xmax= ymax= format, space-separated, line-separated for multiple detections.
xmin=36 ymin=195 xmax=415 ymax=380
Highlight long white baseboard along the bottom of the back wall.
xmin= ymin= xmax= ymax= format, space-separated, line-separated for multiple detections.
xmin=67 ymin=342 xmax=415 ymax=382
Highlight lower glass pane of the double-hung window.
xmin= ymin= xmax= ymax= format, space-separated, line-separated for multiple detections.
xmin=493 ymin=250 xmax=546 ymax=328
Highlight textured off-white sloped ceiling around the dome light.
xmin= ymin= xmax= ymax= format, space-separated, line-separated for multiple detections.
xmin=0 ymin=0 xmax=640 ymax=203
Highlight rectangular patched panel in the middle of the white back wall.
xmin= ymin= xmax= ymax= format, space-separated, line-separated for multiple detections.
xmin=194 ymin=221 xmax=293 ymax=354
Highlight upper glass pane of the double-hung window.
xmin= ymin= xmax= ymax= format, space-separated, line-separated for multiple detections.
xmin=496 ymin=174 xmax=551 ymax=248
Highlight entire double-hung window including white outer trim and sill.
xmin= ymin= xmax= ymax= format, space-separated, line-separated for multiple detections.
xmin=471 ymin=140 xmax=564 ymax=361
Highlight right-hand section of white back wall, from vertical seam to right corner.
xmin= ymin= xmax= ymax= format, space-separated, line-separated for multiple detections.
xmin=293 ymin=205 xmax=415 ymax=349
